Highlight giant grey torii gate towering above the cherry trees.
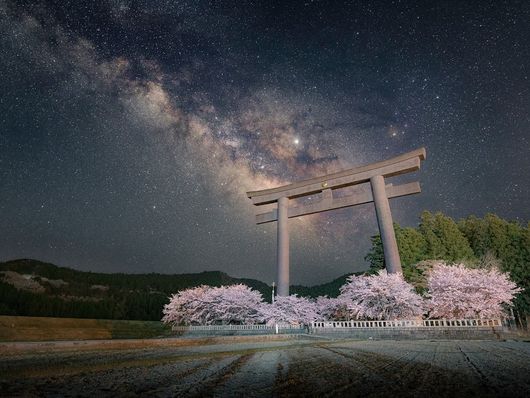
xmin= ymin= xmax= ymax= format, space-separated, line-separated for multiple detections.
xmin=247 ymin=148 xmax=426 ymax=296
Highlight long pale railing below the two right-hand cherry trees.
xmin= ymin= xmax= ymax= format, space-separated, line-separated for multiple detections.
xmin=311 ymin=319 xmax=502 ymax=329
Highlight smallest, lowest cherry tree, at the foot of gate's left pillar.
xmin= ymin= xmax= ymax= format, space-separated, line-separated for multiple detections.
xmin=261 ymin=294 xmax=320 ymax=325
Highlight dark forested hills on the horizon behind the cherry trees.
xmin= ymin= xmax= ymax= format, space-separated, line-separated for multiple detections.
xmin=0 ymin=259 xmax=358 ymax=320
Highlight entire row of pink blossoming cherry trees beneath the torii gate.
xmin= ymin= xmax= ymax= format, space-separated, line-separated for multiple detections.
xmin=162 ymin=260 xmax=521 ymax=326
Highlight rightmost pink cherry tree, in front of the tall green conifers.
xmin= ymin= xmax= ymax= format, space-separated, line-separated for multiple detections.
xmin=427 ymin=262 xmax=521 ymax=319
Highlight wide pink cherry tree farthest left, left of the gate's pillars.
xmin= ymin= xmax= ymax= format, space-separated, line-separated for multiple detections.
xmin=162 ymin=284 xmax=266 ymax=325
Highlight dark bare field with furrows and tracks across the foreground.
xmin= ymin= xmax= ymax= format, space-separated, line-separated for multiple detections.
xmin=0 ymin=338 xmax=530 ymax=398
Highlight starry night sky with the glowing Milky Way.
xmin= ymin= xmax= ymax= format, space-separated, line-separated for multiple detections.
xmin=0 ymin=0 xmax=530 ymax=284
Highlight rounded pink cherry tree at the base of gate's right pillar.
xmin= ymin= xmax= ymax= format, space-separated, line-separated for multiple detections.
xmin=339 ymin=270 xmax=424 ymax=320
